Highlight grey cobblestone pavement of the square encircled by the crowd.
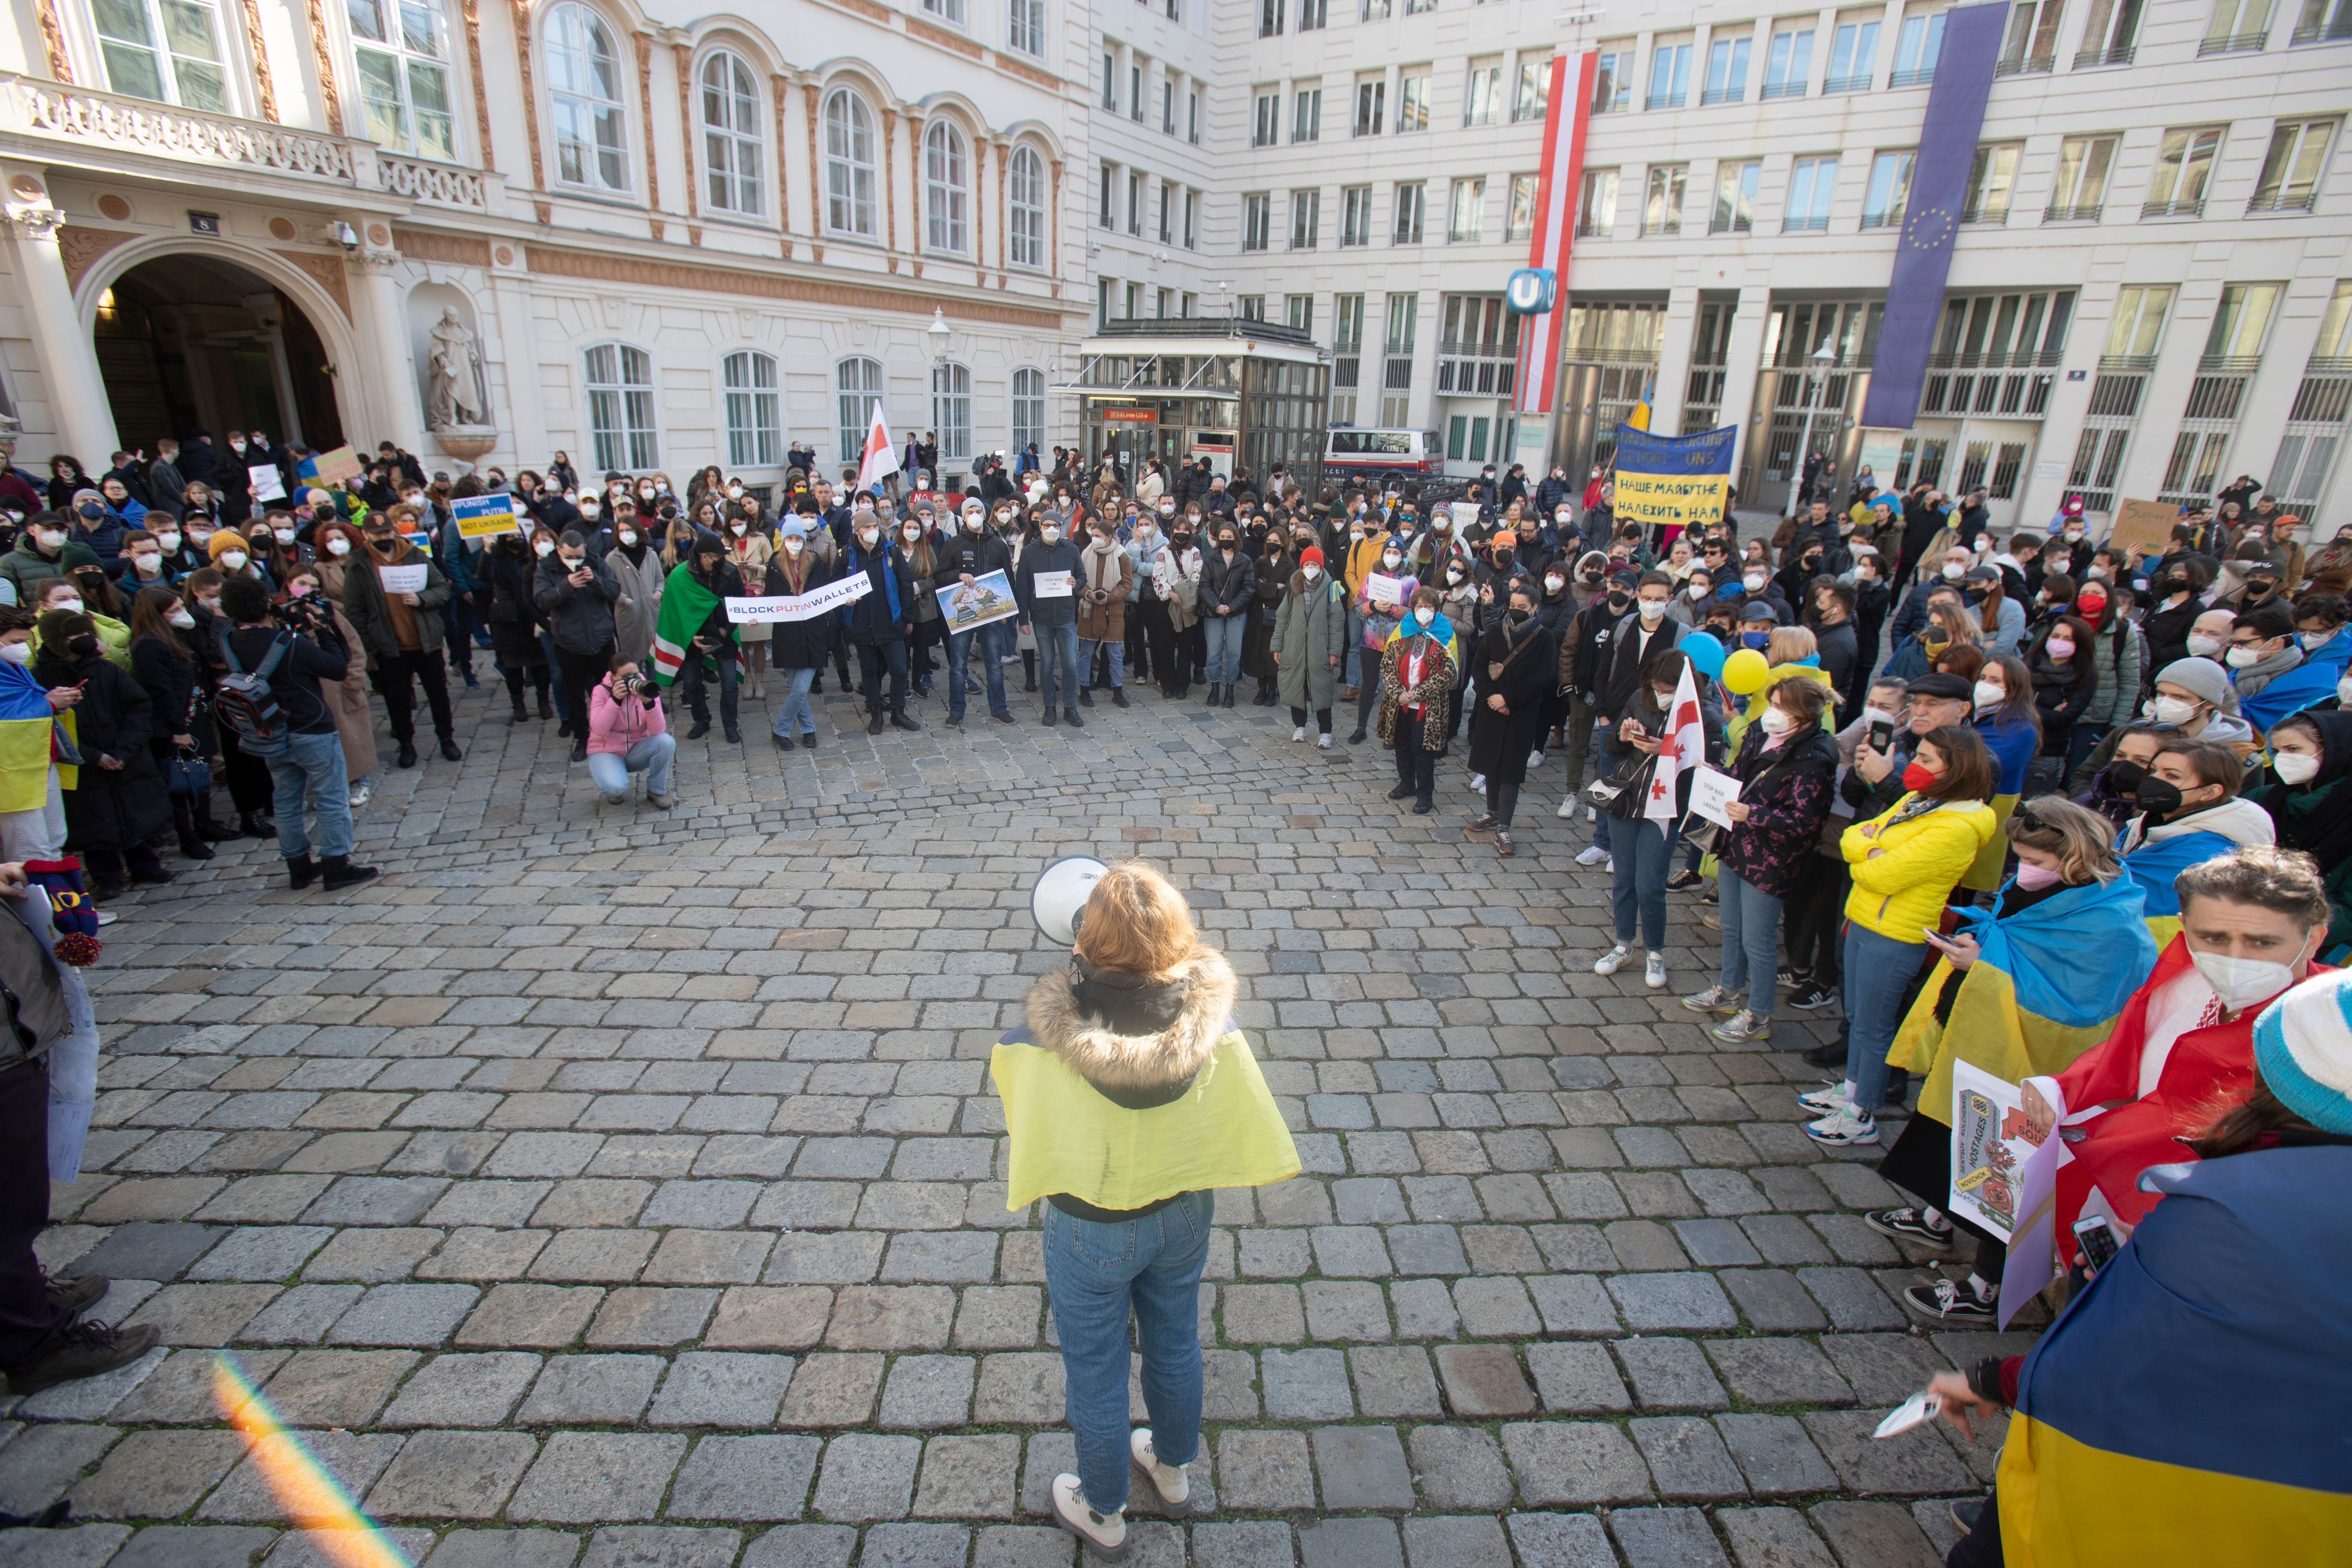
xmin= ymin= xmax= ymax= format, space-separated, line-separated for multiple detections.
xmin=0 ymin=668 xmax=2039 ymax=1568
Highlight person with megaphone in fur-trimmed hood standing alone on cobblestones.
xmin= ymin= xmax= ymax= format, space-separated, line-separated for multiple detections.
xmin=990 ymin=858 xmax=1298 ymax=1561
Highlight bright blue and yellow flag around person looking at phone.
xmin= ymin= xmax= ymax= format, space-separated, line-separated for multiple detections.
xmin=1886 ymin=877 xmax=2157 ymax=1121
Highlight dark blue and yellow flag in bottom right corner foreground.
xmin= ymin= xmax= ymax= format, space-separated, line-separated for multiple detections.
xmin=1999 ymin=1145 xmax=2352 ymax=1568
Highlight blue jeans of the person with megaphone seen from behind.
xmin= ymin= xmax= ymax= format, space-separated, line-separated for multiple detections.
xmin=1044 ymin=1192 xmax=1216 ymax=1514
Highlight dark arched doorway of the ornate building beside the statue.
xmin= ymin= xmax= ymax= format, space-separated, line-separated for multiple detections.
xmin=92 ymin=254 xmax=343 ymax=456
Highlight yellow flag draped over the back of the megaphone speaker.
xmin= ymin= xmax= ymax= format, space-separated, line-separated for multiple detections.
xmin=988 ymin=1030 xmax=1298 ymax=1213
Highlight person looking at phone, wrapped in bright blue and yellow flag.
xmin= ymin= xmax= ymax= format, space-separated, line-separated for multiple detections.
xmin=1863 ymin=795 xmax=2157 ymax=1326
